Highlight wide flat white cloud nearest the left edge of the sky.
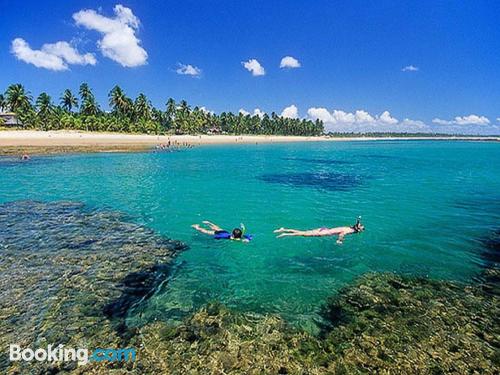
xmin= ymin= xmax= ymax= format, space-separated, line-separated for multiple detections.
xmin=11 ymin=38 xmax=96 ymax=71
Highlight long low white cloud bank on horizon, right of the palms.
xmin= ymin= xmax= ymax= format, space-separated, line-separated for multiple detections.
xmin=307 ymin=107 xmax=431 ymax=133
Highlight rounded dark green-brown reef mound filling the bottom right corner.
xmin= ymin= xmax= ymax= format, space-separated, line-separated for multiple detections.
xmin=324 ymin=274 xmax=500 ymax=374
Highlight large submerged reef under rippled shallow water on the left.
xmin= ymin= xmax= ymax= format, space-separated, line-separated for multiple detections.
xmin=0 ymin=201 xmax=185 ymax=372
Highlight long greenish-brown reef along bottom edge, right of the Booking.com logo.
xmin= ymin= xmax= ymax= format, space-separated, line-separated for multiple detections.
xmin=130 ymin=274 xmax=500 ymax=374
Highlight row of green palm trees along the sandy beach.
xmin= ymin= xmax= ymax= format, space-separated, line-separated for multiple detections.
xmin=0 ymin=83 xmax=324 ymax=136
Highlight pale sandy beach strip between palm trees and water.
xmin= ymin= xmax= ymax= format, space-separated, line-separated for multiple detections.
xmin=0 ymin=130 xmax=500 ymax=154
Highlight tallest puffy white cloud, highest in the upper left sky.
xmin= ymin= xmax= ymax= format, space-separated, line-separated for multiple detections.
xmin=73 ymin=4 xmax=148 ymax=67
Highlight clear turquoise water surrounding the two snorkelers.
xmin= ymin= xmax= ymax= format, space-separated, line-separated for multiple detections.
xmin=0 ymin=141 xmax=500 ymax=325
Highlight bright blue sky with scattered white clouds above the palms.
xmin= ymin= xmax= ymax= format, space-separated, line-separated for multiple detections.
xmin=0 ymin=0 xmax=500 ymax=134
